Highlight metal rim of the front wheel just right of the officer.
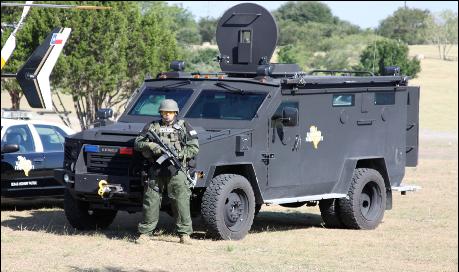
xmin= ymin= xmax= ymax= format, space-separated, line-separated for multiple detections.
xmin=224 ymin=189 xmax=249 ymax=231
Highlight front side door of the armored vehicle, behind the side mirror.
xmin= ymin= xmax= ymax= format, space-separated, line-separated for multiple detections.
xmin=263 ymin=101 xmax=301 ymax=191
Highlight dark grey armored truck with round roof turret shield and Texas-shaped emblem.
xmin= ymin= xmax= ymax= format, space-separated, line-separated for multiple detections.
xmin=56 ymin=4 xmax=419 ymax=240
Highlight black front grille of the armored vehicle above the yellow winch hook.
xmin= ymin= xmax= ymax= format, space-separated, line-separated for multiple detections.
xmin=86 ymin=152 xmax=133 ymax=176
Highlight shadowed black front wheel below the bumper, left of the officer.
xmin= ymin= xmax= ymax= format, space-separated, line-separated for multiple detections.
xmin=64 ymin=190 xmax=117 ymax=230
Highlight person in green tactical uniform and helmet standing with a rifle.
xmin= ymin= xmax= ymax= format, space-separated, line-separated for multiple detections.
xmin=134 ymin=99 xmax=199 ymax=244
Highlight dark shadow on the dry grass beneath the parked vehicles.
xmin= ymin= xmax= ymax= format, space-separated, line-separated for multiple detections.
xmin=1 ymin=205 xmax=328 ymax=242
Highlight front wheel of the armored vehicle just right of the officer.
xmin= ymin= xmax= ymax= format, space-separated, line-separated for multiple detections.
xmin=201 ymin=174 xmax=255 ymax=240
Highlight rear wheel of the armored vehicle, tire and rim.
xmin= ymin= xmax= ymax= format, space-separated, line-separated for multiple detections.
xmin=339 ymin=168 xmax=386 ymax=229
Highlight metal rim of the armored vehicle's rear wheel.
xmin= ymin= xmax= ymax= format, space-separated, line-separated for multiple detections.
xmin=360 ymin=182 xmax=382 ymax=221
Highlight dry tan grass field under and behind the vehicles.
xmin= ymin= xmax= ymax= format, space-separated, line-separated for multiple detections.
xmin=1 ymin=46 xmax=458 ymax=272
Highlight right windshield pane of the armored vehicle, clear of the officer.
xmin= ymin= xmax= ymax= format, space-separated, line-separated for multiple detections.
xmin=186 ymin=90 xmax=266 ymax=120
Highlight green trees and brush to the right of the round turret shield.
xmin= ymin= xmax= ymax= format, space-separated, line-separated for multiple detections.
xmin=274 ymin=1 xmax=457 ymax=77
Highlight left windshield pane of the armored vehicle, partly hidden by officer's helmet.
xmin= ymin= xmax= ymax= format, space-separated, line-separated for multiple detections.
xmin=129 ymin=88 xmax=193 ymax=117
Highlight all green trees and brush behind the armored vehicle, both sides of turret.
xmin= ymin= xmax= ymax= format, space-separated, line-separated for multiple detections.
xmin=1 ymin=1 xmax=457 ymax=129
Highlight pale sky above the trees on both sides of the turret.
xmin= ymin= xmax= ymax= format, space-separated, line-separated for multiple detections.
xmin=167 ymin=1 xmax=458 ymax=28
